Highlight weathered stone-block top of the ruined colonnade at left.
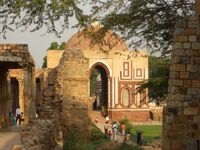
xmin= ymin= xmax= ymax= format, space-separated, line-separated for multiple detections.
xmin=0 ymin=44 xmax=35 ymax=67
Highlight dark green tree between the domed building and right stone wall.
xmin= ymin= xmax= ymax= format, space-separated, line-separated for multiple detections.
xmin=138 ymin=56 xmax=170 ymax=102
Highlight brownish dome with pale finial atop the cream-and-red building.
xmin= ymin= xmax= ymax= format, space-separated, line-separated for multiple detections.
xmin=65 ymin=23 xmax=128 ymax=52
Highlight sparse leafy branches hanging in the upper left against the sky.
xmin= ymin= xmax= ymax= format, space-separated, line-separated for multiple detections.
xmin=0 ymin=0 xmax=87 ymax=38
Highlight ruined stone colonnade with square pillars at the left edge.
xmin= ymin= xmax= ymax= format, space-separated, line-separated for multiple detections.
xmin=0 ymin=44 xmax=35 ymax=128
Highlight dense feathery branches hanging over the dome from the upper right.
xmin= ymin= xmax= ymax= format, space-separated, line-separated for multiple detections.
xmin=90 ymin=0 xmax=194 ymax=55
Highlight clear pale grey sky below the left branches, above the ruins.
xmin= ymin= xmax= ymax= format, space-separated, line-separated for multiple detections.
xmin=0 ymin=26 xmax=78 ymax=68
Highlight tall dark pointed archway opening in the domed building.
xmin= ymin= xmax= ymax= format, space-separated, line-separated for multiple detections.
xmin=90 ymin=62 xmax=110 ymax=115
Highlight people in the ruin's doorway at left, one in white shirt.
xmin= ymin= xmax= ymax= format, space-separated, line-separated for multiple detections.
xmin=9 ymin=106 xmax=23 ymax=125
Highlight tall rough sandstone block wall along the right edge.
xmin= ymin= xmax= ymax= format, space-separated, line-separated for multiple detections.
xmin=163 ymin=16 xmax=200 ymax=150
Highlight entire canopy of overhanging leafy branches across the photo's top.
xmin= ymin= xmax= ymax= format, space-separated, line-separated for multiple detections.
xmin=0 ymin=0 xmax=195 ymax=55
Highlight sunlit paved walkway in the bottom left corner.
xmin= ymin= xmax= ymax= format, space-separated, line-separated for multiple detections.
xmin=0 ymin=125 xmax=22 ymax=150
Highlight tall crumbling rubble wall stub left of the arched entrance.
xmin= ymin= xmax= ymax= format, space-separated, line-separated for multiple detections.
xmin=56 ymin=49 xmax=90 ymax=145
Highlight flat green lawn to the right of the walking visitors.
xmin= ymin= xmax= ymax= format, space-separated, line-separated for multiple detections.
xmin=131 ymin=125 xmax=162 ymax=143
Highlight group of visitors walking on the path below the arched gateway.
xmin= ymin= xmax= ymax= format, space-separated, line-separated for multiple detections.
xmin=104 ymin=119 xmax=130 ymax=142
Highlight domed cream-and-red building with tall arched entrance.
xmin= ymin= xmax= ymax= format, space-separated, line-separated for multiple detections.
xmin=47 ymin=24 xmax=149 ymax=121
